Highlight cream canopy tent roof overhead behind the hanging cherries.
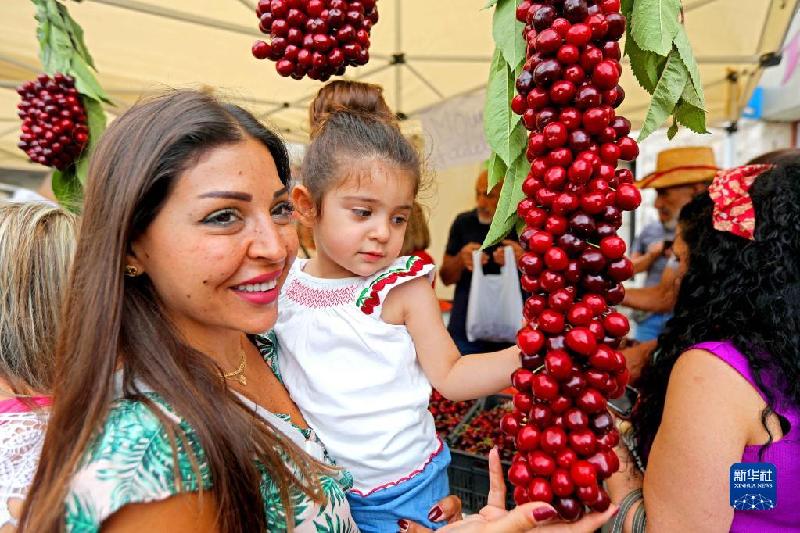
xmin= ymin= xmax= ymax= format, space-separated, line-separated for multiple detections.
xmin=0 ymin=0 xmax=798 ymax=169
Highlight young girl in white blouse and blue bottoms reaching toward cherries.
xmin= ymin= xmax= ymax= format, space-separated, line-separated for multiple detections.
xmin=275 ymin=85 xmax=519 ymax=532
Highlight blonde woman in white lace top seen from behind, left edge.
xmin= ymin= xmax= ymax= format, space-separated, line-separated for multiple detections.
xmin=0 ymin=202 xmax=78 ymax=533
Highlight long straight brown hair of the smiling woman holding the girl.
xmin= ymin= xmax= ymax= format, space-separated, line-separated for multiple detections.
xmin=21 ymin=91 xmax=325 ymax=533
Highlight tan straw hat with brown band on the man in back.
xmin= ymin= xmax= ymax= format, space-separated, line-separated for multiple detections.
xmin=636 ymin=146 xmax=719 ymax=189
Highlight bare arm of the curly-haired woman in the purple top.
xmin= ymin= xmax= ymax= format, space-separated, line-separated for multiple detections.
xmin=609 ymin=350 xmax=764 ymax=533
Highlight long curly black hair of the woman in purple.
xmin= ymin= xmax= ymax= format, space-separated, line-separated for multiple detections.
xmin=632 ymin=157 xmax=800 ymax=462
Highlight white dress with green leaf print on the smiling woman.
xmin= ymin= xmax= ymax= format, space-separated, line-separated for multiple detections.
xmin=65 ymin=336 xmax=358 ymax=533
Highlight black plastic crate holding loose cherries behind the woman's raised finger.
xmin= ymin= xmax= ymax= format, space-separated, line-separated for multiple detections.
xmin=447 ymin=395 xmax=514 ymax=513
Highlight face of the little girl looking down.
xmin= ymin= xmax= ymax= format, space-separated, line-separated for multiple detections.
xmin=314 ymin=161 xmax=415 ymax=278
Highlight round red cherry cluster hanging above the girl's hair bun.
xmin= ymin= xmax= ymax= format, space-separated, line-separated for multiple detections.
xmin=252 ymin=0 xmax=378 ymax=81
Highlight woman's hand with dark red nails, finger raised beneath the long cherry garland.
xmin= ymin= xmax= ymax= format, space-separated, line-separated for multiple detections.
xmin=398 ymin=448 xmax=617 ymax=533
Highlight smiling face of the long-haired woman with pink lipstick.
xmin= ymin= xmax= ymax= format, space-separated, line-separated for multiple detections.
xmin=128 ymin=137 xmax=297 ymax=338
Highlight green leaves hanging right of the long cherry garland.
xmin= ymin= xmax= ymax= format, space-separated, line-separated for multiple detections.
xmin=622 ymin=0 xmax=708 ymax=141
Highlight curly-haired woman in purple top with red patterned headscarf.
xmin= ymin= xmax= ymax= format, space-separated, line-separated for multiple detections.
xmin=609 ymin=158 xmax=800 ymax=533
